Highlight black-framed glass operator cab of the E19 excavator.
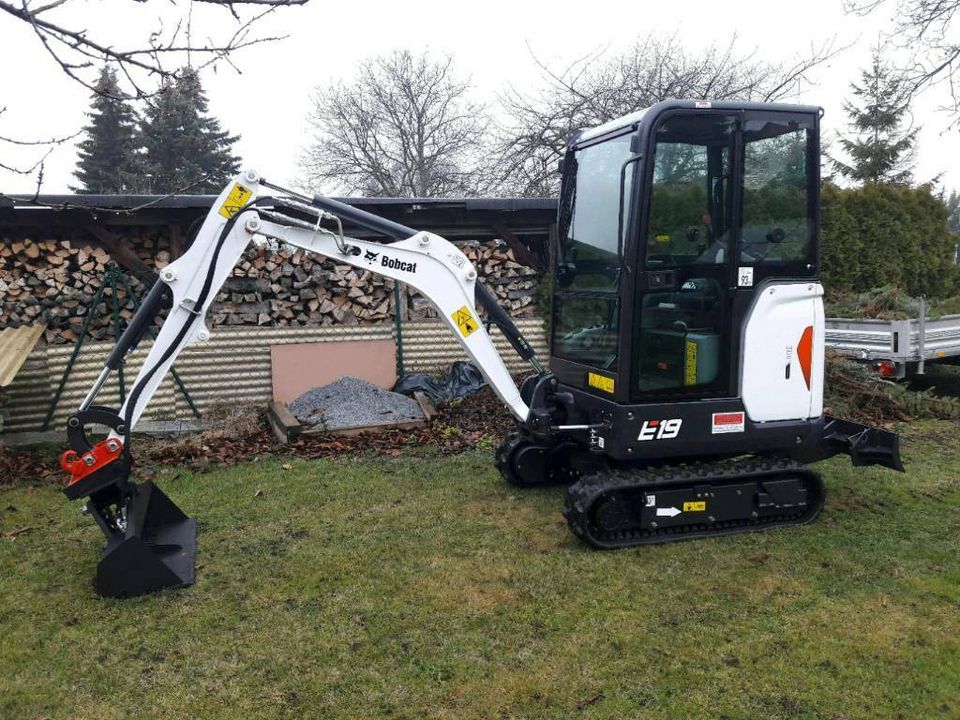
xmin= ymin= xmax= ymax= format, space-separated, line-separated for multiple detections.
xmin=551 ymin=103 xmax=820 ymax=410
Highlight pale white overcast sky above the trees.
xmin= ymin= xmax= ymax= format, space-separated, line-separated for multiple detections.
xmin=0 ymin=0 xmax=960 ymax=193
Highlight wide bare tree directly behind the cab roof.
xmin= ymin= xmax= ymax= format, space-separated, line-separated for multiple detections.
xmin=490 ymin=35 xmax=835 ymax=196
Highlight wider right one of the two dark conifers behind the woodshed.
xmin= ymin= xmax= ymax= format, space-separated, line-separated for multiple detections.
xmin=141 ymin=67 xmax=240 ymax=194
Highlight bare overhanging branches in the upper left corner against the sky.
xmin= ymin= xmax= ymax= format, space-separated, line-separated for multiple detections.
xmin=0 ymin=0 xmax=309 ymax=192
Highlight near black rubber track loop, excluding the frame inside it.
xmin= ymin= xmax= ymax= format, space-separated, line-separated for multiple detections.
xmin=563 ymin=458 xmax=824 ymax=549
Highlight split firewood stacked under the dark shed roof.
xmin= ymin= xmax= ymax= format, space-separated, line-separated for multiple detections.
xmin=0 ymin=234 xmax=537 ymax=343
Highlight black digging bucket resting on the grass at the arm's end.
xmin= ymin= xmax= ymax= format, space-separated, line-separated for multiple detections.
xmin=94 ymin=482 xmax=197 ymax=597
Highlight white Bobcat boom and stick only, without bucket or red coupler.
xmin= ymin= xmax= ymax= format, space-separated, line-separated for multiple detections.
xmin=114 ymin=172 xmax=528 ymax=438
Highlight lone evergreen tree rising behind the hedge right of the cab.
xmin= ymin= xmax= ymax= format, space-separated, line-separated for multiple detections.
xmin=833 ymin=48 xmax=918 ymax=185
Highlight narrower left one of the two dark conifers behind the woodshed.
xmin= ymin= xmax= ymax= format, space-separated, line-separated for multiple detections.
xmin=71 ymin=67 xmax=141 ymax=193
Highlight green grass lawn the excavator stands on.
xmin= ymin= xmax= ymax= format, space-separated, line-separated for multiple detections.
xmin=0 ymin=422 xmax=960 ymax=720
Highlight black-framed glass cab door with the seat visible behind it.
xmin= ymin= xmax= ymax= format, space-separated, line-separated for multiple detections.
xmin=631 ymin=111 xmax=739 ymax=402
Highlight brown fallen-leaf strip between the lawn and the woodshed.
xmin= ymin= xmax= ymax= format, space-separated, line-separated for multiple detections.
xmin=0 ymin=387 xmax=513 ymax=489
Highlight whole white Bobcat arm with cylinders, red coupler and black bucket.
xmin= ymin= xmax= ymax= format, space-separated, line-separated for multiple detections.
xmin=61 ymin=171 xmax=543 ymax=596
